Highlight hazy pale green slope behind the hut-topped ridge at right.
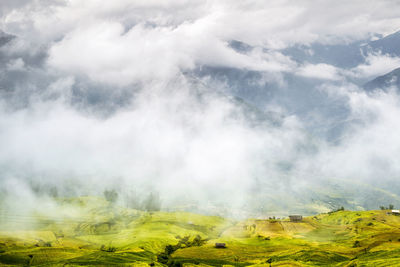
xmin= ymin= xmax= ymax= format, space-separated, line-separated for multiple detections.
xmin=239 ymin=179 xmax=400 ymax=217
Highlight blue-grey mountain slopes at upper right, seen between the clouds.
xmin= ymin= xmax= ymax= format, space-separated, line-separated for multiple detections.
xmin=194 ymin=29 xmax=400 ymax=125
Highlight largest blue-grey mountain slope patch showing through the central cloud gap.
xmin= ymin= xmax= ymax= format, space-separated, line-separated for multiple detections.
xmin=196 ymin=67 xmax=349 ymax=140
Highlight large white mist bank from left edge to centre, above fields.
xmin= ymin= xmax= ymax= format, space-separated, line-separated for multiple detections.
xmin=0 ymin=78 xmax=305 ymax=216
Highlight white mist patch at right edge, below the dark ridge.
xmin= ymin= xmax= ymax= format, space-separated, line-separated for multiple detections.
xmin=312 ymin=88 xmax=400 ymax=186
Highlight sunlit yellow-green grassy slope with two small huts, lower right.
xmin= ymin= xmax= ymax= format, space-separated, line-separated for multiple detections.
xmin=173 ymin=211 xmax=400 ymax=266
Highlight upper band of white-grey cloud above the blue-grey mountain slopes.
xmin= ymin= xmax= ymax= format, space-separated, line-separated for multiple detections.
xmin=0 ymin=0 xmax=400 ymax=85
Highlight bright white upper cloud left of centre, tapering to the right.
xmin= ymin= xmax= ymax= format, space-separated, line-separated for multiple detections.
xmin=48 ymin=21 xmax=294 ymax=86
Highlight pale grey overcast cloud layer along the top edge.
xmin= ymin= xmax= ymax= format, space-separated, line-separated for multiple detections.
xmin=2 ymin=0 xmax=400 ymax=44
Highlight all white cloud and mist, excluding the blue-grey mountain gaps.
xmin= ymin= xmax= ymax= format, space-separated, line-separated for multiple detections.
xmin=0 ymin=0 xmax=400 ymax=216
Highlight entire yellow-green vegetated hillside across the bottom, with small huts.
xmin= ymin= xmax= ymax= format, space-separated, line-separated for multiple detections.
xmin=0 ymin=197 xmax=400 ymax=267
